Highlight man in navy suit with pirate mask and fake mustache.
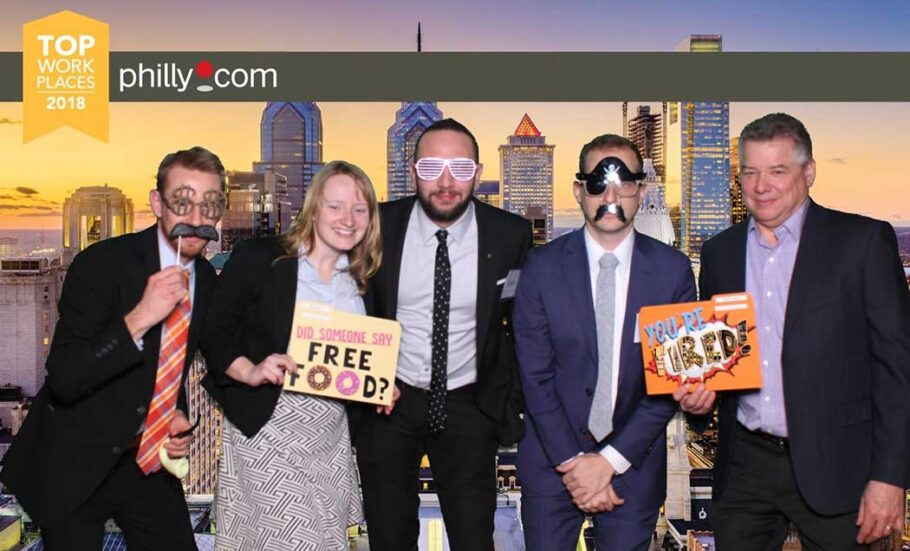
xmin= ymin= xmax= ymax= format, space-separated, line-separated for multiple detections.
xmin=514 ymin=134 xmax=695 ymax=551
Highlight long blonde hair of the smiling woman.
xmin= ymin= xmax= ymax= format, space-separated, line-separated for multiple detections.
xmin=281 ymin=161 xmax=382 ymax=294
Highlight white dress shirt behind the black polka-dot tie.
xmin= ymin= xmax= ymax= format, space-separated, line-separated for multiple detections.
xmin=396 ymin=202 xmax=478 ymax=390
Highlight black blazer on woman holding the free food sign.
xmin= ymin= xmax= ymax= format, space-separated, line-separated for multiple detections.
xmin=201 ymin=237 xmax=297 ymax=437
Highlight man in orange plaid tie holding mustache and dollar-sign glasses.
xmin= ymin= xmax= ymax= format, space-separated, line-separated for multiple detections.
xmin=0 ymin=147 xmax=226 ymax=550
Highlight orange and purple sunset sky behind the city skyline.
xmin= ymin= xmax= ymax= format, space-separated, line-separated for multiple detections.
xmin=0 ymin=0 xmax=910 ymax=229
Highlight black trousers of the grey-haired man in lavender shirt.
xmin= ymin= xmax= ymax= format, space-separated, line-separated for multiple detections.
xmin=711 ymin=423 xmax=867 ymax=551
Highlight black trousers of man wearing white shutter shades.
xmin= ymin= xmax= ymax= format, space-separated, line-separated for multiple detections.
xmin=354 ymin=381 xmax=497 ymax=551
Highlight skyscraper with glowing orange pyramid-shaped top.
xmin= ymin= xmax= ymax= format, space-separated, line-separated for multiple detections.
xmin=499 ymin=113 xmax=556 ymax=241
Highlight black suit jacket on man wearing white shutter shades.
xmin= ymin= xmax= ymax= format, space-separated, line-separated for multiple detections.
xmin=367 ymin=196 xmax=531 ymax=444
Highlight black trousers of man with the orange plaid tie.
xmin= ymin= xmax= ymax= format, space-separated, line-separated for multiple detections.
xmin=41 ymin=449 xmax=197 ymax=551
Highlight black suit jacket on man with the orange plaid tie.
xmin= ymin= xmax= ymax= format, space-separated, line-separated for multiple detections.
xmin=0 ymin=225 xmax=215 ymax=526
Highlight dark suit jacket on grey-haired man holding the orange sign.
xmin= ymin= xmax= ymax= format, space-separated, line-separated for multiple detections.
xmin=699 ymin=201 xmax=910 ymax=515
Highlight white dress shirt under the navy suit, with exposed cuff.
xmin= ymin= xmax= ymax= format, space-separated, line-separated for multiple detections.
xmin=583 ymin=226 xmax=635 ymax=474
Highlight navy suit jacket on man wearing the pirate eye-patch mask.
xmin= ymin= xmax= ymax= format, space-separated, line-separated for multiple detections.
xmin=514 ymin=229 xmax=695 ymax=507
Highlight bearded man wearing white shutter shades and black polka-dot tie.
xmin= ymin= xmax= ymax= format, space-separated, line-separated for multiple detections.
xmin=354 ymin=119 xmax=531 ymax=551
